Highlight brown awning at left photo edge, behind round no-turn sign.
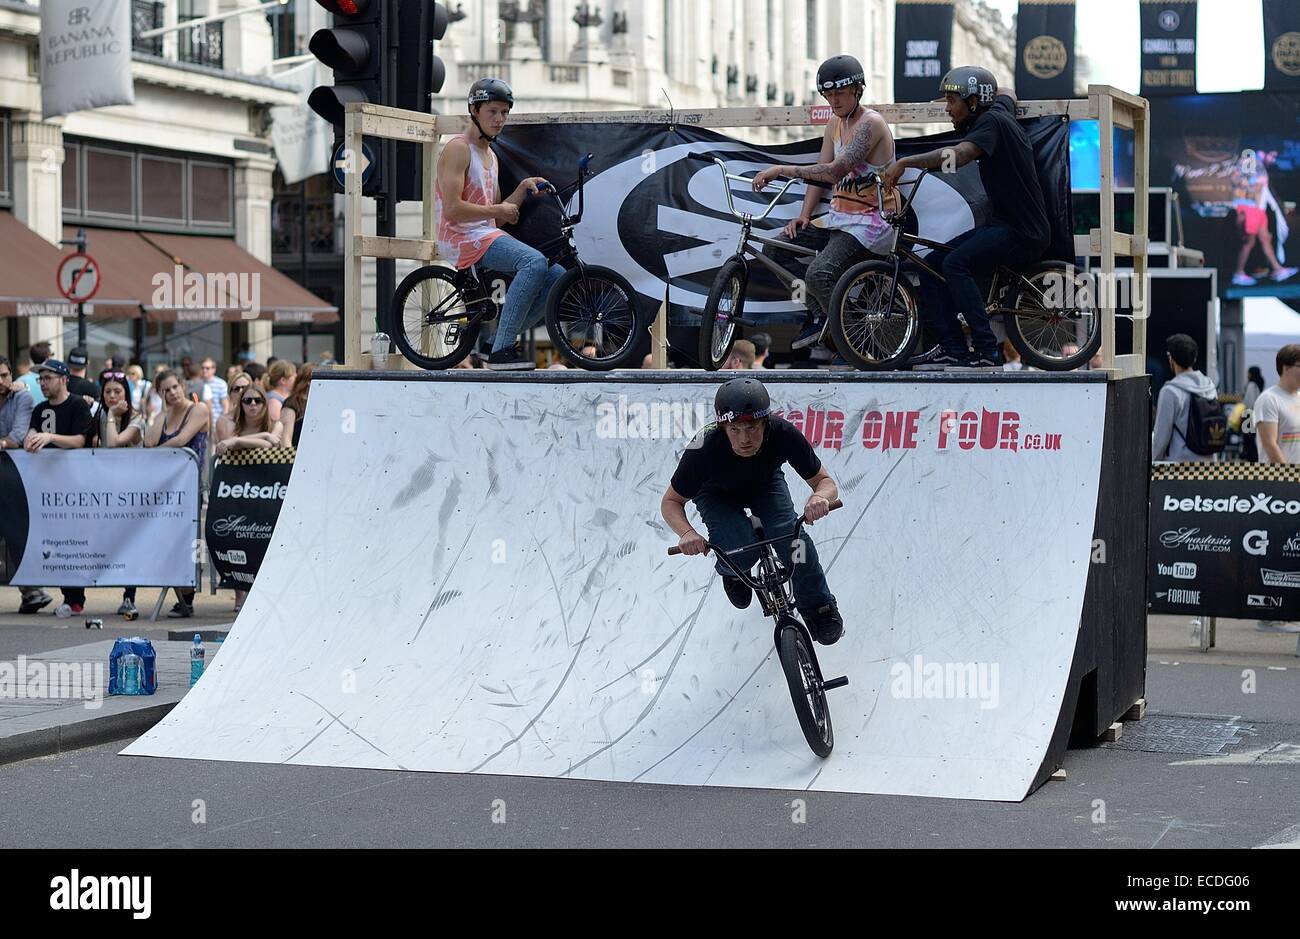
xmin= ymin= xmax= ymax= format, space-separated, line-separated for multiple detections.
xmin=0 ymin=212 xmax=140 ymax=319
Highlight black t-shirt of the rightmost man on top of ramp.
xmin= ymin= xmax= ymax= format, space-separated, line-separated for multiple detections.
xmin=966 ymin=95 xmax=1052 ymax=248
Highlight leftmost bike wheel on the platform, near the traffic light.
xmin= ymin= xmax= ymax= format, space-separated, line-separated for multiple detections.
xmin=386 ymin=264 xmax=495 ymax=368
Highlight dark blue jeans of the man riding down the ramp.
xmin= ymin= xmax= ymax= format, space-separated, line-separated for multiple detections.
xmin=696 ymin=473 xmax=835 ymax=611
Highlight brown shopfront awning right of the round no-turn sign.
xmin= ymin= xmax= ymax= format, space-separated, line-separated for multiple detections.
xmin=56 ymin=226 xmax=338 ymax=323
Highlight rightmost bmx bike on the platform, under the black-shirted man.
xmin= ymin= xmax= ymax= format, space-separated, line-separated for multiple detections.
xmin=829 ymin=170 xmax=1101 ymax=372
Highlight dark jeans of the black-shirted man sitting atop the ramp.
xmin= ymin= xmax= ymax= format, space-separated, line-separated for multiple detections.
xmin=920 ymin=224 xmax=1043 ymax=355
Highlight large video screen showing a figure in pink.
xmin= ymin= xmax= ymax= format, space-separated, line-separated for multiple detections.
xmin=1151 ymin=91 xmax=1300 ymax=297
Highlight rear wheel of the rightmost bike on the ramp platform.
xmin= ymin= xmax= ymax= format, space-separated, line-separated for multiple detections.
xmin=1002 ymin=261 xmax=1101 ymax=372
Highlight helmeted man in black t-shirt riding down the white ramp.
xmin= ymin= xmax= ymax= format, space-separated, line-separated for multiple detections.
xmin=659 ymin=378 xmax=844 ymax=645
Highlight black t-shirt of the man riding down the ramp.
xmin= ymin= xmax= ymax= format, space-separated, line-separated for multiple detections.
xmin=672 ymin=417 xmax=822 ymax=506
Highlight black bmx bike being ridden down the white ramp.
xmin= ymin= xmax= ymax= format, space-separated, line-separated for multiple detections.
xmin=668 ymin=499 xmax=849 ymax=758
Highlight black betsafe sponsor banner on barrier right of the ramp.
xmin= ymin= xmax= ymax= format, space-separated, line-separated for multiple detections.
xmin=1147 ymin=463 xmax=1300 ymax=620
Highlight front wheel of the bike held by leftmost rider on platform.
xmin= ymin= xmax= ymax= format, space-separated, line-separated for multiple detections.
xmin=546 ymin=265 xmax=641 ymax=372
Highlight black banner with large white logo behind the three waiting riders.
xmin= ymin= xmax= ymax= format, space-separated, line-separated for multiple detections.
xmin=493 ymin=112 xmax=1074 ymax=326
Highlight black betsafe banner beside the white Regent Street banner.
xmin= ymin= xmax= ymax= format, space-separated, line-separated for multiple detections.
xmin=203 ymin=447 xmax=294 ymax=590
